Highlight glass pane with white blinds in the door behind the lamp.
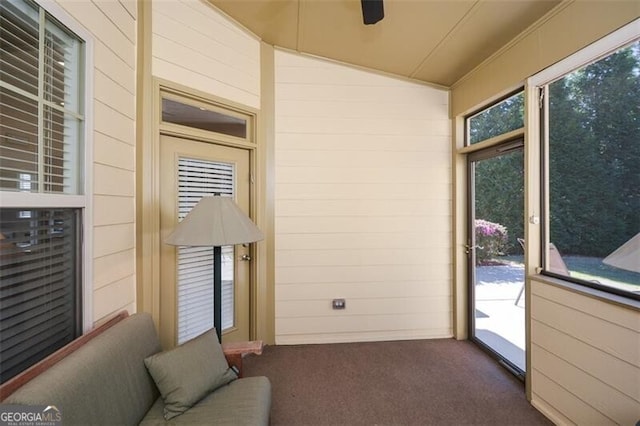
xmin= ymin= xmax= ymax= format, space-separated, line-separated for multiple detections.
xmin=177 ymin=158 xmax=235 ymax=344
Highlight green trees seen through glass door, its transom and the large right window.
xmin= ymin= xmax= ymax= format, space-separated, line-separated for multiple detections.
xmin=469 ymin=42 xmax=640 ymax=257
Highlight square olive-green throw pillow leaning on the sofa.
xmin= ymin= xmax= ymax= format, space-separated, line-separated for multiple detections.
xmin=144 ymin=328 xmax=238 ymax=420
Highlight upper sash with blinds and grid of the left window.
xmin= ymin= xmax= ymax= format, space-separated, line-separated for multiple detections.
xmin=0 ymin=0 xmax=84 ymax=194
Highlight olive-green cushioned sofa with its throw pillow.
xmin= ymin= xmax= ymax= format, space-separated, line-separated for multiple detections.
xmin=0 ymin=313 xmax=271 ymax=425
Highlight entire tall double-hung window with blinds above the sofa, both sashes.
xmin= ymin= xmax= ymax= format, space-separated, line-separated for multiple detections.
xmin=0 ymin=0 xmax=86 ymax=382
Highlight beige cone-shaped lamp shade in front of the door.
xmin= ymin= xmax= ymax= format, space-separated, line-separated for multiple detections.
xmin=165 ymin=196 xmax=264 ymax=247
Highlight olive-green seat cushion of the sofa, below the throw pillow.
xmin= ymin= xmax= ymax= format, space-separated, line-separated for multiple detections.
xmin=140 ymin=377 xmax=271 ymax=426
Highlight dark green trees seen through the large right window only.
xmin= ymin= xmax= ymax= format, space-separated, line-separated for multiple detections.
xmin=548 ymin=43 xmax=640 ymax=257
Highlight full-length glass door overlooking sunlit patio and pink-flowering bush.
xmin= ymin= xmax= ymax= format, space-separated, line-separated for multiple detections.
xmin=467 ymin=139 xmax=527 ymax=377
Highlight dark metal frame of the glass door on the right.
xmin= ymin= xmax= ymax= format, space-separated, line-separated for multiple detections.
xmin=465 ymin=135 xmax=530 ymax=381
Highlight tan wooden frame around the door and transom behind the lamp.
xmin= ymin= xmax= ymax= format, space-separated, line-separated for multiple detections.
xmin=136 ymin=78 xmax=273 ymax=349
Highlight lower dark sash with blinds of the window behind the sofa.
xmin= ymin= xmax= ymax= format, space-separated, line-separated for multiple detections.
xmin=0 ymin=209 xmax=81 ymax=382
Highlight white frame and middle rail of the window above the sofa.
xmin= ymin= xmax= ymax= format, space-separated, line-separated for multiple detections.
xmin=0 ymin=0 xmax=94 ymax=333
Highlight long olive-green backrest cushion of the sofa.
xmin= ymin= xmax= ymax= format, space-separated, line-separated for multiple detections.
xmin=3 ymin=314 xmax=161 ymax=426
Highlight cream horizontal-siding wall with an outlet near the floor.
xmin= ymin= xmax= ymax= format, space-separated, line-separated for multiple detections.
xmin=275 ymin=51 xmax=452 ymax=344
